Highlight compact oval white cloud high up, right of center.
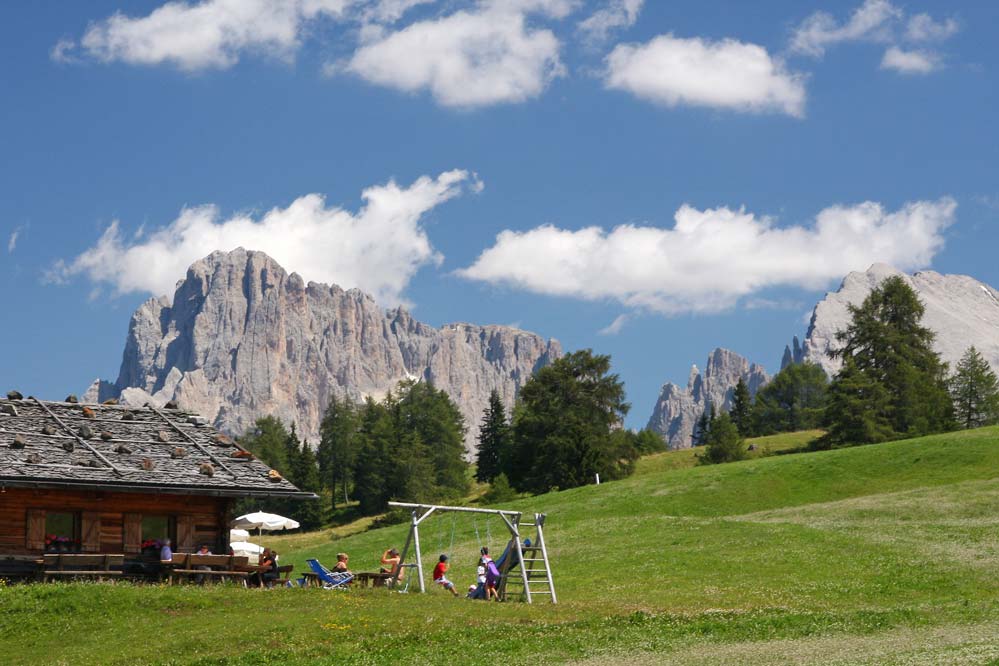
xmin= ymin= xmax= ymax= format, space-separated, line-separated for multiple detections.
xmin=605 ymin=35 xmax=806 ymax=117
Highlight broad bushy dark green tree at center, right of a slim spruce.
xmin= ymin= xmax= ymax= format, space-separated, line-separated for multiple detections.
xmin=504 ymin=350 xmax=637 ymax=493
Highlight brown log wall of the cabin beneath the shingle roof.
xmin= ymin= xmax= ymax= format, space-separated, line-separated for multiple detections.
xmin=0 ymin=488 xmax=232 ymax=555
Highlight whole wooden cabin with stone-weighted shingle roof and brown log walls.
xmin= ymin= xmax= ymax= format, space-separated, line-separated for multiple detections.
xmin=0 ymin=392 xmax=315 ymax=574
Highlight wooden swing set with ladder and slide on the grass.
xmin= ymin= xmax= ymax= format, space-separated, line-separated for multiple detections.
xmin=389 ymin=502 xmax=558 ymax=604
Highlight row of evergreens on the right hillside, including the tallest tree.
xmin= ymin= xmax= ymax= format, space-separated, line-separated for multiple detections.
xmin=693 ymin=276 xmax=999 ymax=462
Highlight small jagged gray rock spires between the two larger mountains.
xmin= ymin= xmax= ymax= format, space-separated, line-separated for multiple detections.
xmin=646 ymin=348 xmax=770 ymax=449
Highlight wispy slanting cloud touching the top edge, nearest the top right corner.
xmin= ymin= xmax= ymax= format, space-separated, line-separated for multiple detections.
xmin=791 ymin=0 xmax=902 ymax=56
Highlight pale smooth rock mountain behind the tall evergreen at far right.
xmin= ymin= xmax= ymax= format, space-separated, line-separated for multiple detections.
xmin=803 ymin=264 xmax=999 ymax=376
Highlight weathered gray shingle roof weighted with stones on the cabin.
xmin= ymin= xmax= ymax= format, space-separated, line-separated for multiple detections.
xmin=0 ymin=394 xmax=314 ymax=498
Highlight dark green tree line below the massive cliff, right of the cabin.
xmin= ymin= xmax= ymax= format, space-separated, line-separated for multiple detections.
xmin=241 ymin=350 xmax=664 ymax=528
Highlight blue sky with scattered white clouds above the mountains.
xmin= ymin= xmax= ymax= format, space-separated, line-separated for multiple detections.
xmin=0 ymin=0 xmax=999 ymax=426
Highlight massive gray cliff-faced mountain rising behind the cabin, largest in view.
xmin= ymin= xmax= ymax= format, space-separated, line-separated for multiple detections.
xmin=94 ymin=249 xmax=562 ymax=451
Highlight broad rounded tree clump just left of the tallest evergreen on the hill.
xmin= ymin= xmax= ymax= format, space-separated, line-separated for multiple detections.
xmin=752 ymin=362 xmax=829 ymax=435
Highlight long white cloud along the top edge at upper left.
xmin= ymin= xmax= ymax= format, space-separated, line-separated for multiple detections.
xmin=60 ymin=0 xmax=353 ymax=71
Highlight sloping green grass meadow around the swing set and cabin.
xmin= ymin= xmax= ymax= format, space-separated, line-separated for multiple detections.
xmin=0 ymin=428 xmax=999 ymax=665
